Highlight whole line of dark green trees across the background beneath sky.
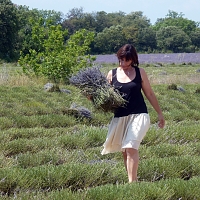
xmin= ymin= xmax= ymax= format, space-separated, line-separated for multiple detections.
xmin=0 ymin=0 xmax=200 ymax=61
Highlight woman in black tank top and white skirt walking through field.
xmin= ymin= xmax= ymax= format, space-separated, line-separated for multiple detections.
xmin=102 ymin=44 xmax=165 ymax=183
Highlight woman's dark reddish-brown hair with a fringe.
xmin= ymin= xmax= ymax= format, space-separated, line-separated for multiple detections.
xmin=117 ymin=44 xmax=139 ymax=67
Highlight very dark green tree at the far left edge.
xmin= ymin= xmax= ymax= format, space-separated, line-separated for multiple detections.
xmin=0 ymin=0 xmax=19 ymax=60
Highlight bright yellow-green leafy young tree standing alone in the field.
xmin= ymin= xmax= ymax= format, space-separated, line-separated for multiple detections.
xmin=19 ymin=22 xmax=94 ymax=84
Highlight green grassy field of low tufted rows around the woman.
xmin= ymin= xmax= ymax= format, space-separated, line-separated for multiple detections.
xmin=0 ymin=56 xmax=200 ymax=200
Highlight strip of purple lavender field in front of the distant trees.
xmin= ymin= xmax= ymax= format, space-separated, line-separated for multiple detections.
xmin=95 ymin=53 xmax=200 ymax=64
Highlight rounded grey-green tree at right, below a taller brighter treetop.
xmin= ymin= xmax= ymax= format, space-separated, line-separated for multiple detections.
xmin=156 ymin=26 xmax=191 ymax=53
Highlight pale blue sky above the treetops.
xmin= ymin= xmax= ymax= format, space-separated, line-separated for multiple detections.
xmin=11 ymin=0 xmax=200 ymax=24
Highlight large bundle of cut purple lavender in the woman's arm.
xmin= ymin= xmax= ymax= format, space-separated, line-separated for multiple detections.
xmin=69 ymin=66 xmax=125 ymax=112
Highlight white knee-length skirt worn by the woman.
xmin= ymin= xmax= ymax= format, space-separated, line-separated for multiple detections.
xmin=101 ymin=113 xmax=150 ymax=155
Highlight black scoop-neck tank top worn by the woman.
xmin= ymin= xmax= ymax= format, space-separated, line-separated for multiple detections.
xmin=111 ymin=67 xmax=148 ymax=117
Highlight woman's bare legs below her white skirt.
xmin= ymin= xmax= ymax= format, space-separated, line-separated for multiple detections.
xmin=123 ymin=148 xmax=139 ymax=183
